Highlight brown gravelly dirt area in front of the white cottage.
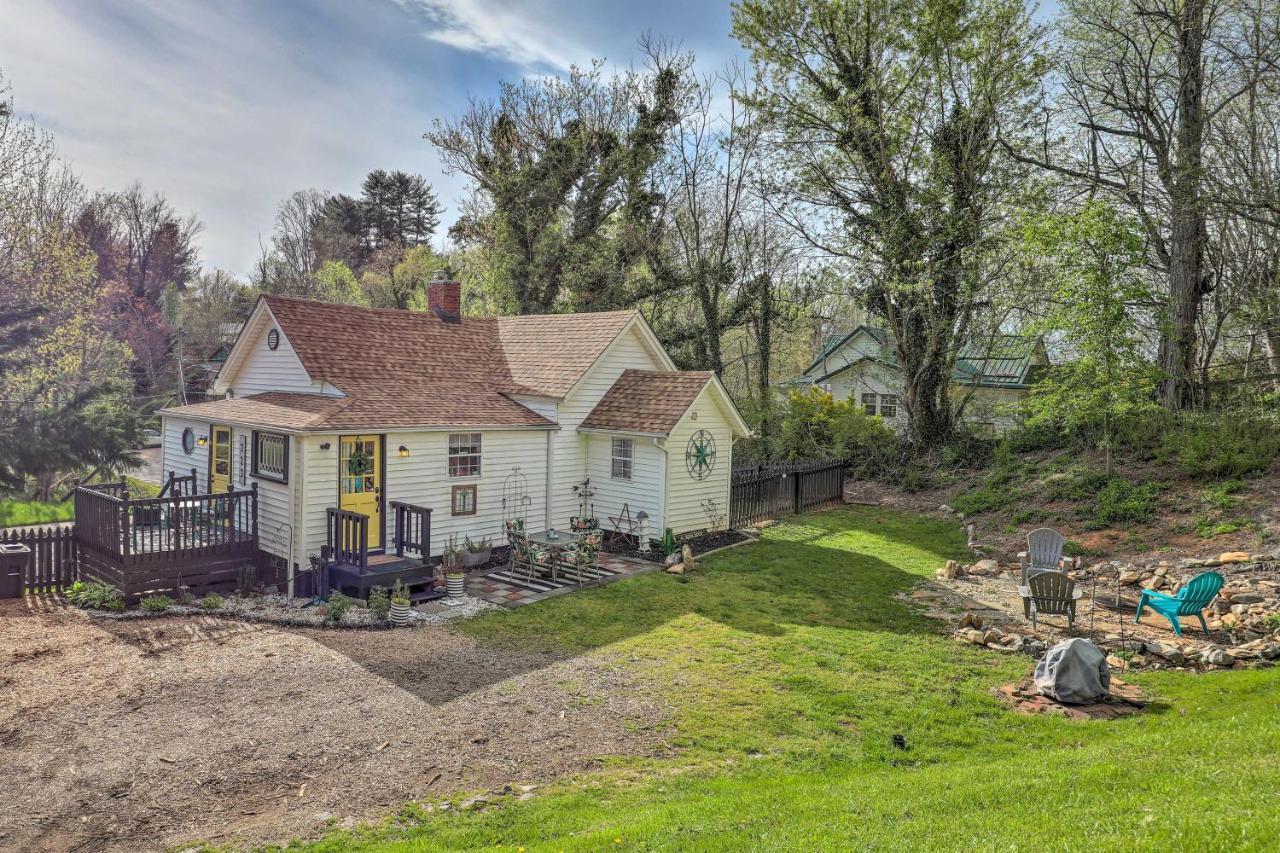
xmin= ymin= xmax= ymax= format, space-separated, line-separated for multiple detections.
xmin=0 ymin=602 xmax=667 ymax=850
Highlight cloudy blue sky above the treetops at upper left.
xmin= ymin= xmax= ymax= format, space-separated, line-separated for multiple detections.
xmin=0 ymin=0 xmax=737 ymax=274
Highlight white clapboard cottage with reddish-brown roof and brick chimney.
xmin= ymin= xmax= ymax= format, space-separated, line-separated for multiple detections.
xmin=160 ymin=280 xmax=749 ymax=581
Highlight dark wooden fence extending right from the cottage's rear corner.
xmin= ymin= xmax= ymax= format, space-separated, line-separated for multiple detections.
xmin=730 ymin=460 xmax=849 ymax=526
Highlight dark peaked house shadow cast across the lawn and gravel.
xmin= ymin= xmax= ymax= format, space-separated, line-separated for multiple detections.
xmin=308 ymin=507 xmax=964 ymax=703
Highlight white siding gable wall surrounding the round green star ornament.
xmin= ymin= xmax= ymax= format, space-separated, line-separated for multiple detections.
xmin=666 ymin=384 xmax=733 ymax=535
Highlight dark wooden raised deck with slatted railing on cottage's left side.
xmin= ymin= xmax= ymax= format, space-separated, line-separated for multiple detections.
xmin=74 ymin=478 xmax=264 ymax=599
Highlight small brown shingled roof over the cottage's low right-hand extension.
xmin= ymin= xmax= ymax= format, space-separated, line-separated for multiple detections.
xmin=581 ymin=370 xmax=714 ymax=435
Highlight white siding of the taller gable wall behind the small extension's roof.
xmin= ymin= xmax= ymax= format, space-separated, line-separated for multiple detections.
xmin=550 ymin=325 xmax=664 ymax=526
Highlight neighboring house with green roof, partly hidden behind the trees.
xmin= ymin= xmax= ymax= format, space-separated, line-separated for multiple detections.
xmin=787 ymin=325 xmax=1048 ymax=433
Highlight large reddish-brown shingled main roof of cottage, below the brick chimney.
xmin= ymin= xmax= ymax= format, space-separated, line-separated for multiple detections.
xmin=163 ymin=296 xmax=635 ymax=430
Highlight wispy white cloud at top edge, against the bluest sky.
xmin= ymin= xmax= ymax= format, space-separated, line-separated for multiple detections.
xmin=398 ymin=0 xmax=593 ymax=70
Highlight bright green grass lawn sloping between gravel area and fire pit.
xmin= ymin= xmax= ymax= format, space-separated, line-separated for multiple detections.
xmin=294 ymin=508 xmax=1280 ymax=850
